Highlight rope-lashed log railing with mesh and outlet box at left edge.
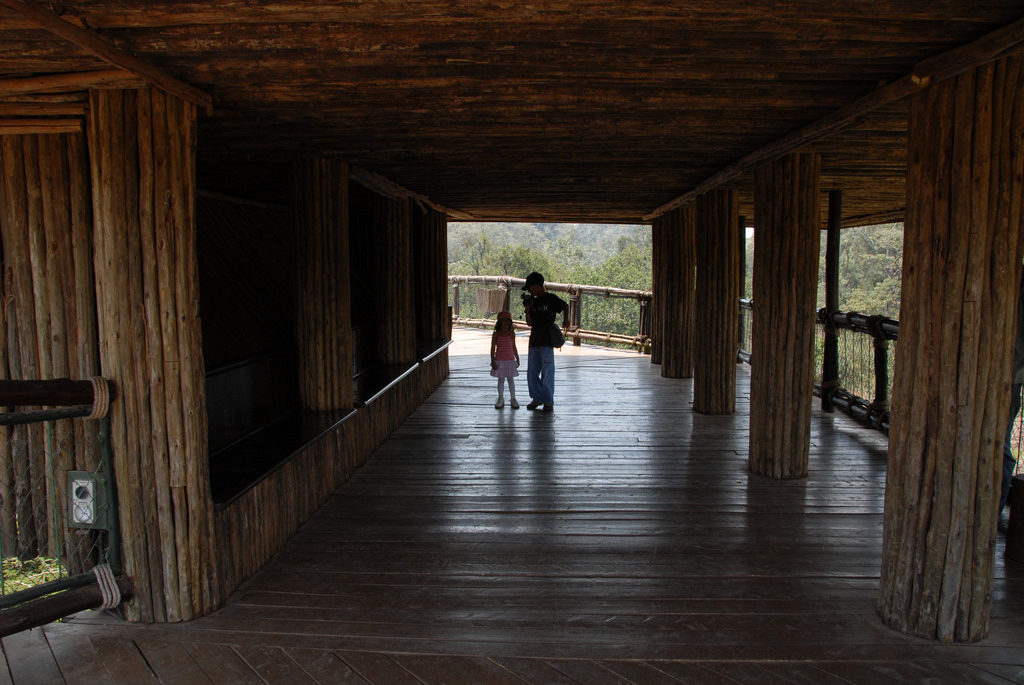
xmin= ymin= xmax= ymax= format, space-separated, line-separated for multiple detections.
xmin=0 ymin=378 xmax=131 ymax=637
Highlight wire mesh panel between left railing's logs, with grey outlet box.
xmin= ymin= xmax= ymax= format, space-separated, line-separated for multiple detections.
xmin=0 ymin=414 xmax=117 ymax=595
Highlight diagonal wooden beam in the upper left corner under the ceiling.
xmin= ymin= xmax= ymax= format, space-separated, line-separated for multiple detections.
xmin=0 ymin=0 xmax=213 ymax=114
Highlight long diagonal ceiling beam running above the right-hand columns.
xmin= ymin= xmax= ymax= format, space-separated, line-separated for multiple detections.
xmin=642 ymin=13 xmax=1024 ymax=221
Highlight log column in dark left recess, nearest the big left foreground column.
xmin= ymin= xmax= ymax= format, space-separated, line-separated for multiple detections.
xmin=292 ymin=159 xmax=352 ymax=411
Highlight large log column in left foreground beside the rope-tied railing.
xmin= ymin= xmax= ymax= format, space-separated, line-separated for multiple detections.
xmin=88 ymin=90 xmax=219 ymax=622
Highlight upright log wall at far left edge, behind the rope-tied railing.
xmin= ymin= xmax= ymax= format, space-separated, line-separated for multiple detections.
xmin=0 ymin=133 xmax=99 ymax=573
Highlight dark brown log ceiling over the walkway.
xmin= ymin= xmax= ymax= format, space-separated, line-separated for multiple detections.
xmin=0 ymin=0 xmax=1024 ymax=223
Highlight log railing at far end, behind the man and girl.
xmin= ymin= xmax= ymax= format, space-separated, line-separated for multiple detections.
xmin=449 ymin=275 xmax=651 ymax=352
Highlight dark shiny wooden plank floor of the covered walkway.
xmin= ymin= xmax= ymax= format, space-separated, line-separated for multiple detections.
xmin=8 ymin=331 xmax=1024 ymax=685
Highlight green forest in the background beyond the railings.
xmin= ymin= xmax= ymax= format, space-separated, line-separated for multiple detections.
xmin=449 ymin=221 xmax=903 ymax=335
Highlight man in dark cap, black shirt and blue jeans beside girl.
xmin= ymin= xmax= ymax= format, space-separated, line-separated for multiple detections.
xmin=522 ymin=271 xmax=568 ymax=412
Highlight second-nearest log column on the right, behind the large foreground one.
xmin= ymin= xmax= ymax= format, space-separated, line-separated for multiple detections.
xmin=750 ymin=154 xmax=821 ymax=478
